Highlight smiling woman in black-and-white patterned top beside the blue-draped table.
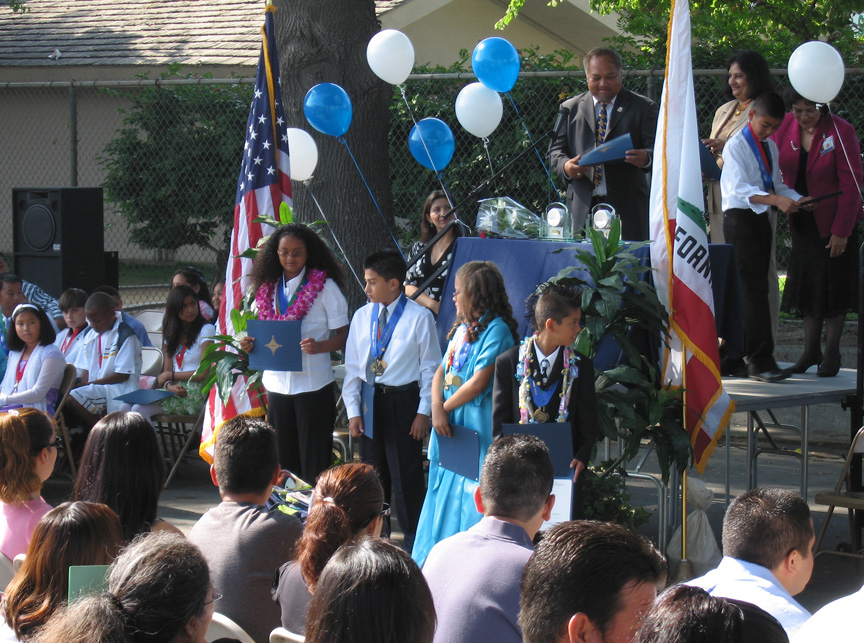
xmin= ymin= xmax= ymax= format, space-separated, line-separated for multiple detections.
xmin=405 ymin=190 xmax=459 ymax=315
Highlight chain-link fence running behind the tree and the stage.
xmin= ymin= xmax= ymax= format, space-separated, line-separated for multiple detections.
xmin=0 ymin=69 xmax=864 ymax=307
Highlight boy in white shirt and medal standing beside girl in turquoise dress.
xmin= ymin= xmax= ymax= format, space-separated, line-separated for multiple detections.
xmin=342 ymin=252 xmax=441 ymax=551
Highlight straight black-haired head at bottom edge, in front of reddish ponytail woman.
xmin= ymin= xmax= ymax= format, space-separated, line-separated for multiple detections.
xmin=306 ymin=538 xmax=436 ymax=643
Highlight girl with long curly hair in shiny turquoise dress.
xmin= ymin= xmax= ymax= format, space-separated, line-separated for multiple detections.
xmin=411 ymin=261 xmax=518 ymax=565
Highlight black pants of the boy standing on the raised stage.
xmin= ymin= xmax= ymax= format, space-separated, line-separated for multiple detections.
xmin=723 ymin=208 xmax=777 ymax=374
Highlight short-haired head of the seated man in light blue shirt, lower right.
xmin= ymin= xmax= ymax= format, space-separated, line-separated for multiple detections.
xmin=723 ymin=488 xmax=816 ymax=596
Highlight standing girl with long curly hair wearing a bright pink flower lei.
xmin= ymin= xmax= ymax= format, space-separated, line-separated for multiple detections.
xmin=240 ymin=223 xmax=348 ymax=483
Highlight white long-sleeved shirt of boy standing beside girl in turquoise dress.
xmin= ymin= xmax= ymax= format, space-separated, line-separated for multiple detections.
xmin=342 ymin=298 xmax=441 ymax=418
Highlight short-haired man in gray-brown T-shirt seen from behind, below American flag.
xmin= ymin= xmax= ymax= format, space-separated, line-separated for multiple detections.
xmin=189 ymin=417 xmax=303 ymax=643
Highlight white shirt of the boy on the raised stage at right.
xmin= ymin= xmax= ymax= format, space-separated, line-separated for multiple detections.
xmin=720 ymin=125 xmax=801 ymax=214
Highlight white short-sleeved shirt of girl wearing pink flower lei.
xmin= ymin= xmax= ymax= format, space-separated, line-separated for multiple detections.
xmin=261 ymin=268 xmax=348 ymax=395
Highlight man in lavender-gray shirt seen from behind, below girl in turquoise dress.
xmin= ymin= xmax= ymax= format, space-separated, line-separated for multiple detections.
xmin=423 ymin=435 xmax=555 ymax=643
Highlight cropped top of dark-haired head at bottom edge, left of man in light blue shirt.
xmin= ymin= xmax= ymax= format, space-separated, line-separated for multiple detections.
xmin=634 ymin=585 xmax=744 ymax=643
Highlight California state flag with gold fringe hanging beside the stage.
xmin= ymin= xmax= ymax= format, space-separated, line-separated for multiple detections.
xmin=651 ymin=0 xmax=735 ymax=473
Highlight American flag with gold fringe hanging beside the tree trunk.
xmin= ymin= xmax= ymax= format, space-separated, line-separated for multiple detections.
xmin=199 ymin=5 xmax=291 ymax=463
